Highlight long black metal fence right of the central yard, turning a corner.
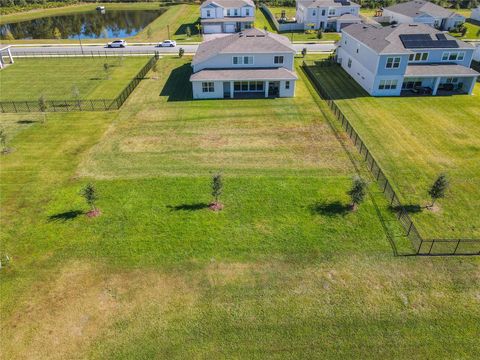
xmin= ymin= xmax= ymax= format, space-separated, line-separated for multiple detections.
xmin=302 ymin=60 xmax=480 ymax=255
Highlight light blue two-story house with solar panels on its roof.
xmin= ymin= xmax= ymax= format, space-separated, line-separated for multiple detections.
xmin=337 ymin=24 xmax=480 ymax=96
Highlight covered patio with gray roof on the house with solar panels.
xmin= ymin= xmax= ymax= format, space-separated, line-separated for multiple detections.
xmin=401 ymin=64 xmax=480 ymax=96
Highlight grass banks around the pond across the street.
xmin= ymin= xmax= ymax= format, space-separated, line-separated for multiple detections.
xmin=0 ymin=2 xmax=201 ymax=44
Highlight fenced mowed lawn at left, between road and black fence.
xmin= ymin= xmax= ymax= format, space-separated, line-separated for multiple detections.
xmin=0 ymin=57 xmax=148 ymax=101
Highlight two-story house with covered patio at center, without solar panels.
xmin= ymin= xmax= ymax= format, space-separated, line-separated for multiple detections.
xmin=190 ymin=29 xmax=297 ymax=99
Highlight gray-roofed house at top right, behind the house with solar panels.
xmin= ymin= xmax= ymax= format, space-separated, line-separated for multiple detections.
xmin=383 ymin=0 xmax=465 ymax=30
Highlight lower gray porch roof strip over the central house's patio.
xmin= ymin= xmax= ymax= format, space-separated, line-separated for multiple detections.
xmin=190 ymin=68 xmax=298 ymax=81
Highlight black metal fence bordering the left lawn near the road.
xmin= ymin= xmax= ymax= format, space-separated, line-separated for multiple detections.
xmin=0 ymin=56 xmax=157 ymax=113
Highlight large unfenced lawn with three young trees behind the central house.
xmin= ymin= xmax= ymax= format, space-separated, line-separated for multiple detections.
xmin=0 ymin=58 xmax=480 ymax=359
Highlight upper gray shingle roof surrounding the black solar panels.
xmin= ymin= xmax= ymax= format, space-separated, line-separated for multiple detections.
xmin=342 ymin=24 xmax=473 ymax=54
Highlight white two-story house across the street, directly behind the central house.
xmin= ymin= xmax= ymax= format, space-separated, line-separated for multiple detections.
xmin=200 ymin=0 xmax=255 ymax=34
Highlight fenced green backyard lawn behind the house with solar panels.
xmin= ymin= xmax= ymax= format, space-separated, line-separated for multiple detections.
xmin=314 ymin=67 xmax=480 ymax=238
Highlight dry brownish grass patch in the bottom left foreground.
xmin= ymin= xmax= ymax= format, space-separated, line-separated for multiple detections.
xmin=2 ymin=262 xmax=195 ymax=359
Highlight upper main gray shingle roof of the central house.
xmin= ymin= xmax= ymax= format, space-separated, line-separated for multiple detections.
xmin=192 ymin=29 xmax=295 ymax=65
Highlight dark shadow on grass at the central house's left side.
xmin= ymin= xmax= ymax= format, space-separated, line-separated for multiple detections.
xmin=160 ymin=63 xmax=193 ymax=101
